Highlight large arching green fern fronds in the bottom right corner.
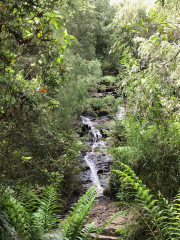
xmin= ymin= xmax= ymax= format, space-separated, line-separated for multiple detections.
xmin=114 ymin=162 xmax=180 ymax=240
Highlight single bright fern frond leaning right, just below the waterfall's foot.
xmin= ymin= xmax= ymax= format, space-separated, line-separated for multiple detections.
xmin=60 ymin=186 xmax=97 ymax=240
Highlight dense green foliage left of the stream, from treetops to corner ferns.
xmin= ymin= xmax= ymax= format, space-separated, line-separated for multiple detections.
xmin=0 ymin=0 xmax=119 ymax=239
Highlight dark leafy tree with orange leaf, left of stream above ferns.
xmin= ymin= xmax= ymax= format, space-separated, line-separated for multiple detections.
xmin=0 ymin=0 xmax=88 ymax=189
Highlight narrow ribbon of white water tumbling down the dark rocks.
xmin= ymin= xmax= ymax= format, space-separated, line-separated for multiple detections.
xmin=81 ymin=116 xmax=102 ymax=193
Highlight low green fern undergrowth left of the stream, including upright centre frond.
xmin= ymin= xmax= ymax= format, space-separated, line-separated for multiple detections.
xmin=0 ymin=186 xmax=127 ymax=240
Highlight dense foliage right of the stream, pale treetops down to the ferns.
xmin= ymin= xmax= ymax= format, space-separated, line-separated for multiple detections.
xmin=107 ymin=0 xmax=180 ymax=239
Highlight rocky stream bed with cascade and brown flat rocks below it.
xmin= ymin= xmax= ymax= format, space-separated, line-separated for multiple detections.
xmin=74 ymin=107 xmax=133 ymax=240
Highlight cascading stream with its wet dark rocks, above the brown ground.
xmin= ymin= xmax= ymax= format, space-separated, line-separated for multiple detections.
xmin=80 ymin=106 xmax=126 ymax=196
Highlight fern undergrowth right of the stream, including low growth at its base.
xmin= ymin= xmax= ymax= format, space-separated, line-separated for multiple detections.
xmin=114 ymin=162 xmax=180 ymax=240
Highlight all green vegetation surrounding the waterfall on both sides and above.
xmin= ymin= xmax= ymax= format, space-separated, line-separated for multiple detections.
xmin=0 ymin=0 xmax=180 ymax=240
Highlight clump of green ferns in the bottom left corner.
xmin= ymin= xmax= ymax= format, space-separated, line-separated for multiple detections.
xmin=0 ymin=186 xmax=58 ymax=240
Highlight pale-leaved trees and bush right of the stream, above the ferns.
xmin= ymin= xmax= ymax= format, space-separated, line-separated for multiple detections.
xmin=109 ymin=1 xmax=180 ymax=199
